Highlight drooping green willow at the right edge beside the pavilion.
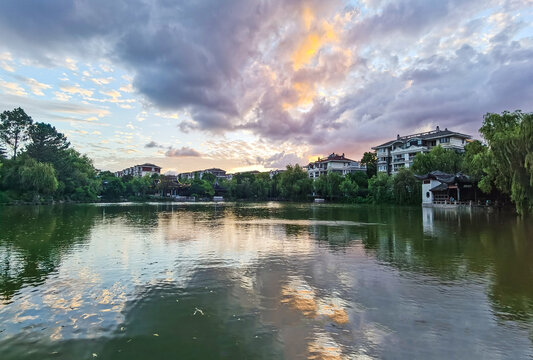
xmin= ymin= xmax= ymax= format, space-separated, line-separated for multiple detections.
xmin=479 ymin=111 xmax=533 ymax=214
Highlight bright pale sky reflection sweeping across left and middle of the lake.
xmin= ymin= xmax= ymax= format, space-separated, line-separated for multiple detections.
xmin=2 ymin=208 xmax=322 ymax=341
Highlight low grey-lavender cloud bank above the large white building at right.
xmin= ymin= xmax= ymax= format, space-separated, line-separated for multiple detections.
xmin=317 ymin=38 xmax=533 ymax=156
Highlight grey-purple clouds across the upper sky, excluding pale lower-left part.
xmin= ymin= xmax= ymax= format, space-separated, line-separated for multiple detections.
xmin=0 ymin=0 xmax=533 ymax=157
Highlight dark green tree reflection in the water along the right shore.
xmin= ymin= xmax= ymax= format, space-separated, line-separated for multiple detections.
xmin=363 ymin=205 xmax=533 ymax=319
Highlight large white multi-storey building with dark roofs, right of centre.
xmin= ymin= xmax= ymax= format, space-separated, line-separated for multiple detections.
xmin=372 ymin=126 xmax=472 ymax=174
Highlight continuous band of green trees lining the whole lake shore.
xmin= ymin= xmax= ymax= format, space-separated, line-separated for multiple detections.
xmin=0 ymin=108 xmax=533 ymax=215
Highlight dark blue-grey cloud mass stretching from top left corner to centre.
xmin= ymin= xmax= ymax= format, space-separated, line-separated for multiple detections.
xmin=0 ymin=0 xmax=340 ymax=131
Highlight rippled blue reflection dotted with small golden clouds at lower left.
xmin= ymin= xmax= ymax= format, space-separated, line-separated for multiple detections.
xmin=2 ymin=266 xmax=127 ymax=341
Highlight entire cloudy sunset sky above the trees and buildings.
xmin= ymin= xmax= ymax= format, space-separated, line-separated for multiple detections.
xmin=0 ymin=0 xmax=533 ymax=172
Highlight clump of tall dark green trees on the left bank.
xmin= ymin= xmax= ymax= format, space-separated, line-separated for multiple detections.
xmin=0 ymin=108 xmax=101 ymax=202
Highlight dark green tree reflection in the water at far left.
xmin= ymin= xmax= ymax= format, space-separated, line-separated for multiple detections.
xmin=0 ymin=206 xmax=99 ymax=300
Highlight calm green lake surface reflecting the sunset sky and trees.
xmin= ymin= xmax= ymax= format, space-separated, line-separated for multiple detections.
xmin=0 ymin=203 xmax=533 ymax=360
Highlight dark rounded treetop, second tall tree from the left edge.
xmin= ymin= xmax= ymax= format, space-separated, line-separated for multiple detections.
xmin=26 ymin=122 xmax=70 ymax=162
